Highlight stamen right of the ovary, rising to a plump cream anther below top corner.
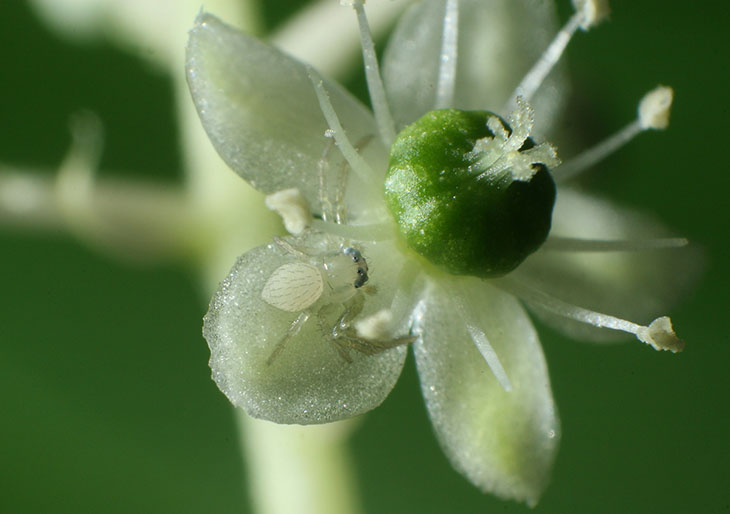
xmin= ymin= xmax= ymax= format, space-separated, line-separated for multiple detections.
xmin=552 ymin=86 xmax=673 ymax=182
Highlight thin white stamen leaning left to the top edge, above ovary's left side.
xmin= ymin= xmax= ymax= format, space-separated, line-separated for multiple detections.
xmin=352 ymin=0 xmax=395 ymax=144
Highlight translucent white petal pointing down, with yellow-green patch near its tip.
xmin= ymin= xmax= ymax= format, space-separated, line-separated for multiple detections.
xmin=414 ymin=279 xmax=559 ymax=504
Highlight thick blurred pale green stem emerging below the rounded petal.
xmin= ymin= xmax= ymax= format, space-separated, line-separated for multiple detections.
xmin=236 ymin=409 xmax=362 ymax=514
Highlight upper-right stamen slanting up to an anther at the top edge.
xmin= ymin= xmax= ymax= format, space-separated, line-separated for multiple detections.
xmin=505 ymin=0 xmax=608 ymax=111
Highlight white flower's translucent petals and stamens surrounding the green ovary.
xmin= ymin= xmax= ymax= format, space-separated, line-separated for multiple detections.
xmin=187 ymin=0 xmax=683 ymax=503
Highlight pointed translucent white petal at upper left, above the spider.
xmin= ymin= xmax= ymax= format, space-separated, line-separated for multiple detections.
xmin=186 ymin=14 xmax=387 ymax=221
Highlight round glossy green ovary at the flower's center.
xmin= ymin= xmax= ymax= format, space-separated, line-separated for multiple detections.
xmin=385 ymin=109 xmax=555 ymax=277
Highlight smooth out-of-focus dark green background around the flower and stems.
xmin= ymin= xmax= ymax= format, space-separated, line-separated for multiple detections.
xmin=0 ymin=0 xmax=730 ymax=514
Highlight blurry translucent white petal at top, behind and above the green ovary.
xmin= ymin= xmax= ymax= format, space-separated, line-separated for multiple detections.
xmin=383 ymin=0 xmax=563 ymax=135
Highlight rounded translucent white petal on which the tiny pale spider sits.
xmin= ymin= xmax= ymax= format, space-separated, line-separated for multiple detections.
xmin=203 ymin=232 xmax=406 ymax=424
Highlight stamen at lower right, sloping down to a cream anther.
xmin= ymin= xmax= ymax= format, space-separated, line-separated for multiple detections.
xmin=493 ymin=278 xmax=684 ymax=353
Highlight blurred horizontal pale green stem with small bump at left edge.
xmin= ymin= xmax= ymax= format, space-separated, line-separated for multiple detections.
xmin=0 ymin=162 xmax=195 ymax=261
